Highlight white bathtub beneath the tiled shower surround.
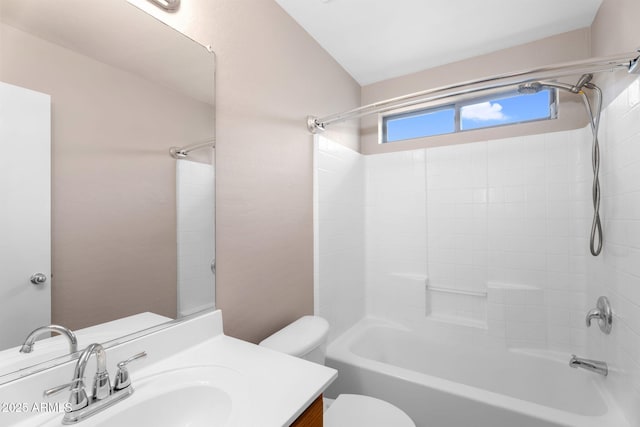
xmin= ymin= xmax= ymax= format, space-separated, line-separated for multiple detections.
xmin=325 ymin=319 xmax=629 ymax=427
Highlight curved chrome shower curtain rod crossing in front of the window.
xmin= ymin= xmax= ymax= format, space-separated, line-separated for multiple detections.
xmin=307 ymin=49 xmax=640 ymax=133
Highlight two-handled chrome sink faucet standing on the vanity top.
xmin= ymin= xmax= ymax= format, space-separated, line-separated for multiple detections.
xmin=44 ymin=343 xmax=147 ymax=424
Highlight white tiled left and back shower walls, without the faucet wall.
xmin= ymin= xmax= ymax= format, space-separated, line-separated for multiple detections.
xmin=317 ymin=129 xmax=590 ymax=352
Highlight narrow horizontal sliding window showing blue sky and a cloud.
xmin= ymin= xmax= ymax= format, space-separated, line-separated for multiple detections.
xmin=379 ymin=89 xmax=557 ymax=143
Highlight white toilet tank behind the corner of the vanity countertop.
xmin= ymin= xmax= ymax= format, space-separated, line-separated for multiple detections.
xmin=260 ymin=316 xmax=329 ymax=365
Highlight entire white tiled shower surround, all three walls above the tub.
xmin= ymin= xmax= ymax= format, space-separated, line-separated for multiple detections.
xmin=319 ymin=78 xmax=640 ymax=376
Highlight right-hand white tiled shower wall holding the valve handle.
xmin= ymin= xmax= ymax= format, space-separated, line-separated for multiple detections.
xmin=587 ymin=80 xmax=640 ymax=426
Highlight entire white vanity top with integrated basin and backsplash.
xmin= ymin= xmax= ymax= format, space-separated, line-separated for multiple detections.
xmin=0 ymin=310 xmax=336 ymax=427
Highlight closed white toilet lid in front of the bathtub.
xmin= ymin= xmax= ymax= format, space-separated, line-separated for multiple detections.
xmin=324 ymin=394 xmax=416 ymax=427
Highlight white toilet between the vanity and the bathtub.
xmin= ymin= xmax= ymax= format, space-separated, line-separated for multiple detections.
xmin=260 ymin=316 xmax=416 ymax=427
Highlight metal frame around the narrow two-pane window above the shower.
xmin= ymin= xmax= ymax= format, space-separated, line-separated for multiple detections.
xmin=378 ymin=88 xmax=559 ymax=144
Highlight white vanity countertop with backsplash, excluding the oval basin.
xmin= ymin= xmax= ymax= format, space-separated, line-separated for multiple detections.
xmin=0 ymin=310 xmax=337 ymax=427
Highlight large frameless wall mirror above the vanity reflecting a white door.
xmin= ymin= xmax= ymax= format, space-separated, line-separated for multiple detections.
xmin=0 ymin=0 xmax=215 ymax=382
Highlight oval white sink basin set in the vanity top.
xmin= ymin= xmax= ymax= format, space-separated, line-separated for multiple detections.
xmin=91 ymin=366 xmax=247 ymax=427
